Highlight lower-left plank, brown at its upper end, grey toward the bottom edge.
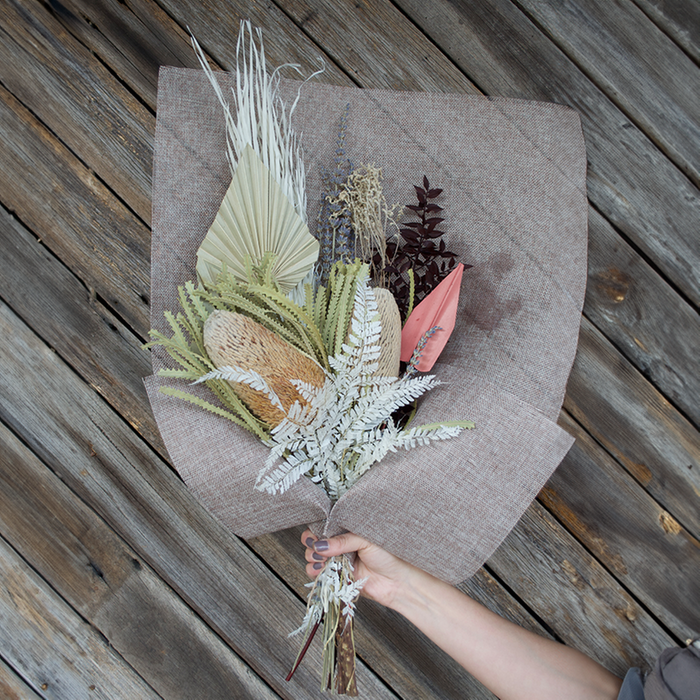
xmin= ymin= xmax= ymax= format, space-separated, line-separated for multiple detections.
xmin=0 ymin=426 xmax=278 ymax=700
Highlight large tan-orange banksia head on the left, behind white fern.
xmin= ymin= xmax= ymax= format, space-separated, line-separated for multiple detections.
xmin=204 ymin=311 xmax=325 ymax=428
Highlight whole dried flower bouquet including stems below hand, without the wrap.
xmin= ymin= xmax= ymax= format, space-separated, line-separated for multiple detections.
xmin=148 ymin=24 xmax=474 ymax=695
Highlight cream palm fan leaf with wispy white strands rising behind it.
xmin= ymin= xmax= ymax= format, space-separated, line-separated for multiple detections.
xmin=192 ymin=22 xmax=319 ymax=299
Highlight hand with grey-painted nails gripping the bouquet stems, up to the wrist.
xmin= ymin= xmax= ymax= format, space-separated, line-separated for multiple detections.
xmin=301 ymin=530 xmax=419 ymax=607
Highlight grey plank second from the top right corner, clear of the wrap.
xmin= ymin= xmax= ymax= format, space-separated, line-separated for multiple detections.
xmin=504 ymin=0 xmax=700 ymax=187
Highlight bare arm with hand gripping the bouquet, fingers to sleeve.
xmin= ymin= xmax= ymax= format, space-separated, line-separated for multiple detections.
xmin=301 ymin=530 xmax=621 ymax=700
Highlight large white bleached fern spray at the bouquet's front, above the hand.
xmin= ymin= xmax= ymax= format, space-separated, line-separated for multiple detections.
xmin=256 ymin=275 xmax=473 ymax=500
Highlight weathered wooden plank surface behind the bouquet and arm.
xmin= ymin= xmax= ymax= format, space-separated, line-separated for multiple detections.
xmin=0 ymin=0 xmax=700 ymax=700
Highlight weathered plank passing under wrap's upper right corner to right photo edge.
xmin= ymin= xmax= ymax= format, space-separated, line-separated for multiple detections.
xmin=398 ymin=0 xmax=700 ymax=305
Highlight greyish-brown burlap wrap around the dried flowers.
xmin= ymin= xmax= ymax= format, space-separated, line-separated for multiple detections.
xmin=146 ymin=68 xmax=587 ymax=583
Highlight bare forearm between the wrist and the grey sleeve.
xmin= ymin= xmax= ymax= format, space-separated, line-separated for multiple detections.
xmin=391 ymin=569 xmax=620 ymax=700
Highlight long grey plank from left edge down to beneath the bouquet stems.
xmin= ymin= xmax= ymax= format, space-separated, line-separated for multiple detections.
xmin=0 ymin=305 xmax=394 ymax=698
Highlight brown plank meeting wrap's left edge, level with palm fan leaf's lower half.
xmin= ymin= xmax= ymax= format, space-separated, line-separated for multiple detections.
xmin=0 ymin=80 xmax=150 ymax=337
